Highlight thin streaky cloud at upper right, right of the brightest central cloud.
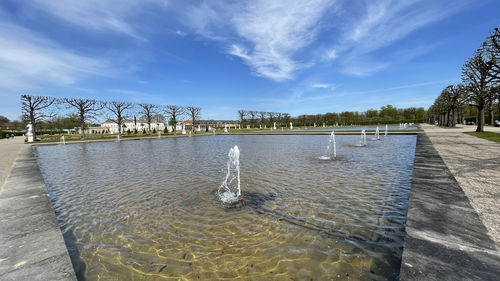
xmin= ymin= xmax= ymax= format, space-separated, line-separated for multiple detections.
xmin=330 ymin=0 xmax=471 ymax=76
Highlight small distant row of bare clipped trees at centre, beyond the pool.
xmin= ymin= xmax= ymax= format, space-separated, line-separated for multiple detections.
xmin=238 ymin=109 xmax=291 ymax=128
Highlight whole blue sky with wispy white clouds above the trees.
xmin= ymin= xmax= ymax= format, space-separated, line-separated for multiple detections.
xmin=0 ymin=0 xmax=500 ymax=120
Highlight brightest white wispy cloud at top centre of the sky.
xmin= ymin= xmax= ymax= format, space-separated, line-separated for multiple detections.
xmin=189 ymin=0 xmax=334 ymax=81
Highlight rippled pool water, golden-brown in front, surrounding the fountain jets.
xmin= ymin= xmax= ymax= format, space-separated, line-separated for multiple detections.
xmin=37 ymin=135 xmax=416 ymax=280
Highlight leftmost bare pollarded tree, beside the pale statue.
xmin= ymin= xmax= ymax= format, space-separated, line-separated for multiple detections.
xmin=21 ymin=95 xmax=57 ymax=140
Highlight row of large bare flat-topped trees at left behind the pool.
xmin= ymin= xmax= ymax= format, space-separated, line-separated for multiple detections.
xmin=21 ymin=95 xmax=201 ymax=138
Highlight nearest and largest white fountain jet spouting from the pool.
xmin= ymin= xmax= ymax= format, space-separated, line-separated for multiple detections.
xmin=217 ymin=145 xmax=243 ymax=203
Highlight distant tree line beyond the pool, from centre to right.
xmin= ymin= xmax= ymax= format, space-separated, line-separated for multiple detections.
xmin=238 ymin=104 xmax=427 ymax=128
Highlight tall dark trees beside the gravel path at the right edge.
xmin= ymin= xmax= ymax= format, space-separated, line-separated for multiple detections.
xmin=428 ymin=28 xmax=500 ymax=132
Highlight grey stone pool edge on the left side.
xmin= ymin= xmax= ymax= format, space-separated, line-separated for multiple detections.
xmin=0 ymin=145 xmax=77 ymax=281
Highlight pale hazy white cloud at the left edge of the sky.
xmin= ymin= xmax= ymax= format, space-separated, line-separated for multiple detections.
xmin=0 ymin=22 xmax=113 ymax=91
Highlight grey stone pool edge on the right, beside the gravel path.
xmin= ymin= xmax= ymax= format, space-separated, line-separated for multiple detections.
xmin=400 ymin=133 xmax=500 ymax=280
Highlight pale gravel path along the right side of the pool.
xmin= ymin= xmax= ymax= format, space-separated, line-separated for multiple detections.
xmin=422 ymin=125 xmax=500 ymax=246
